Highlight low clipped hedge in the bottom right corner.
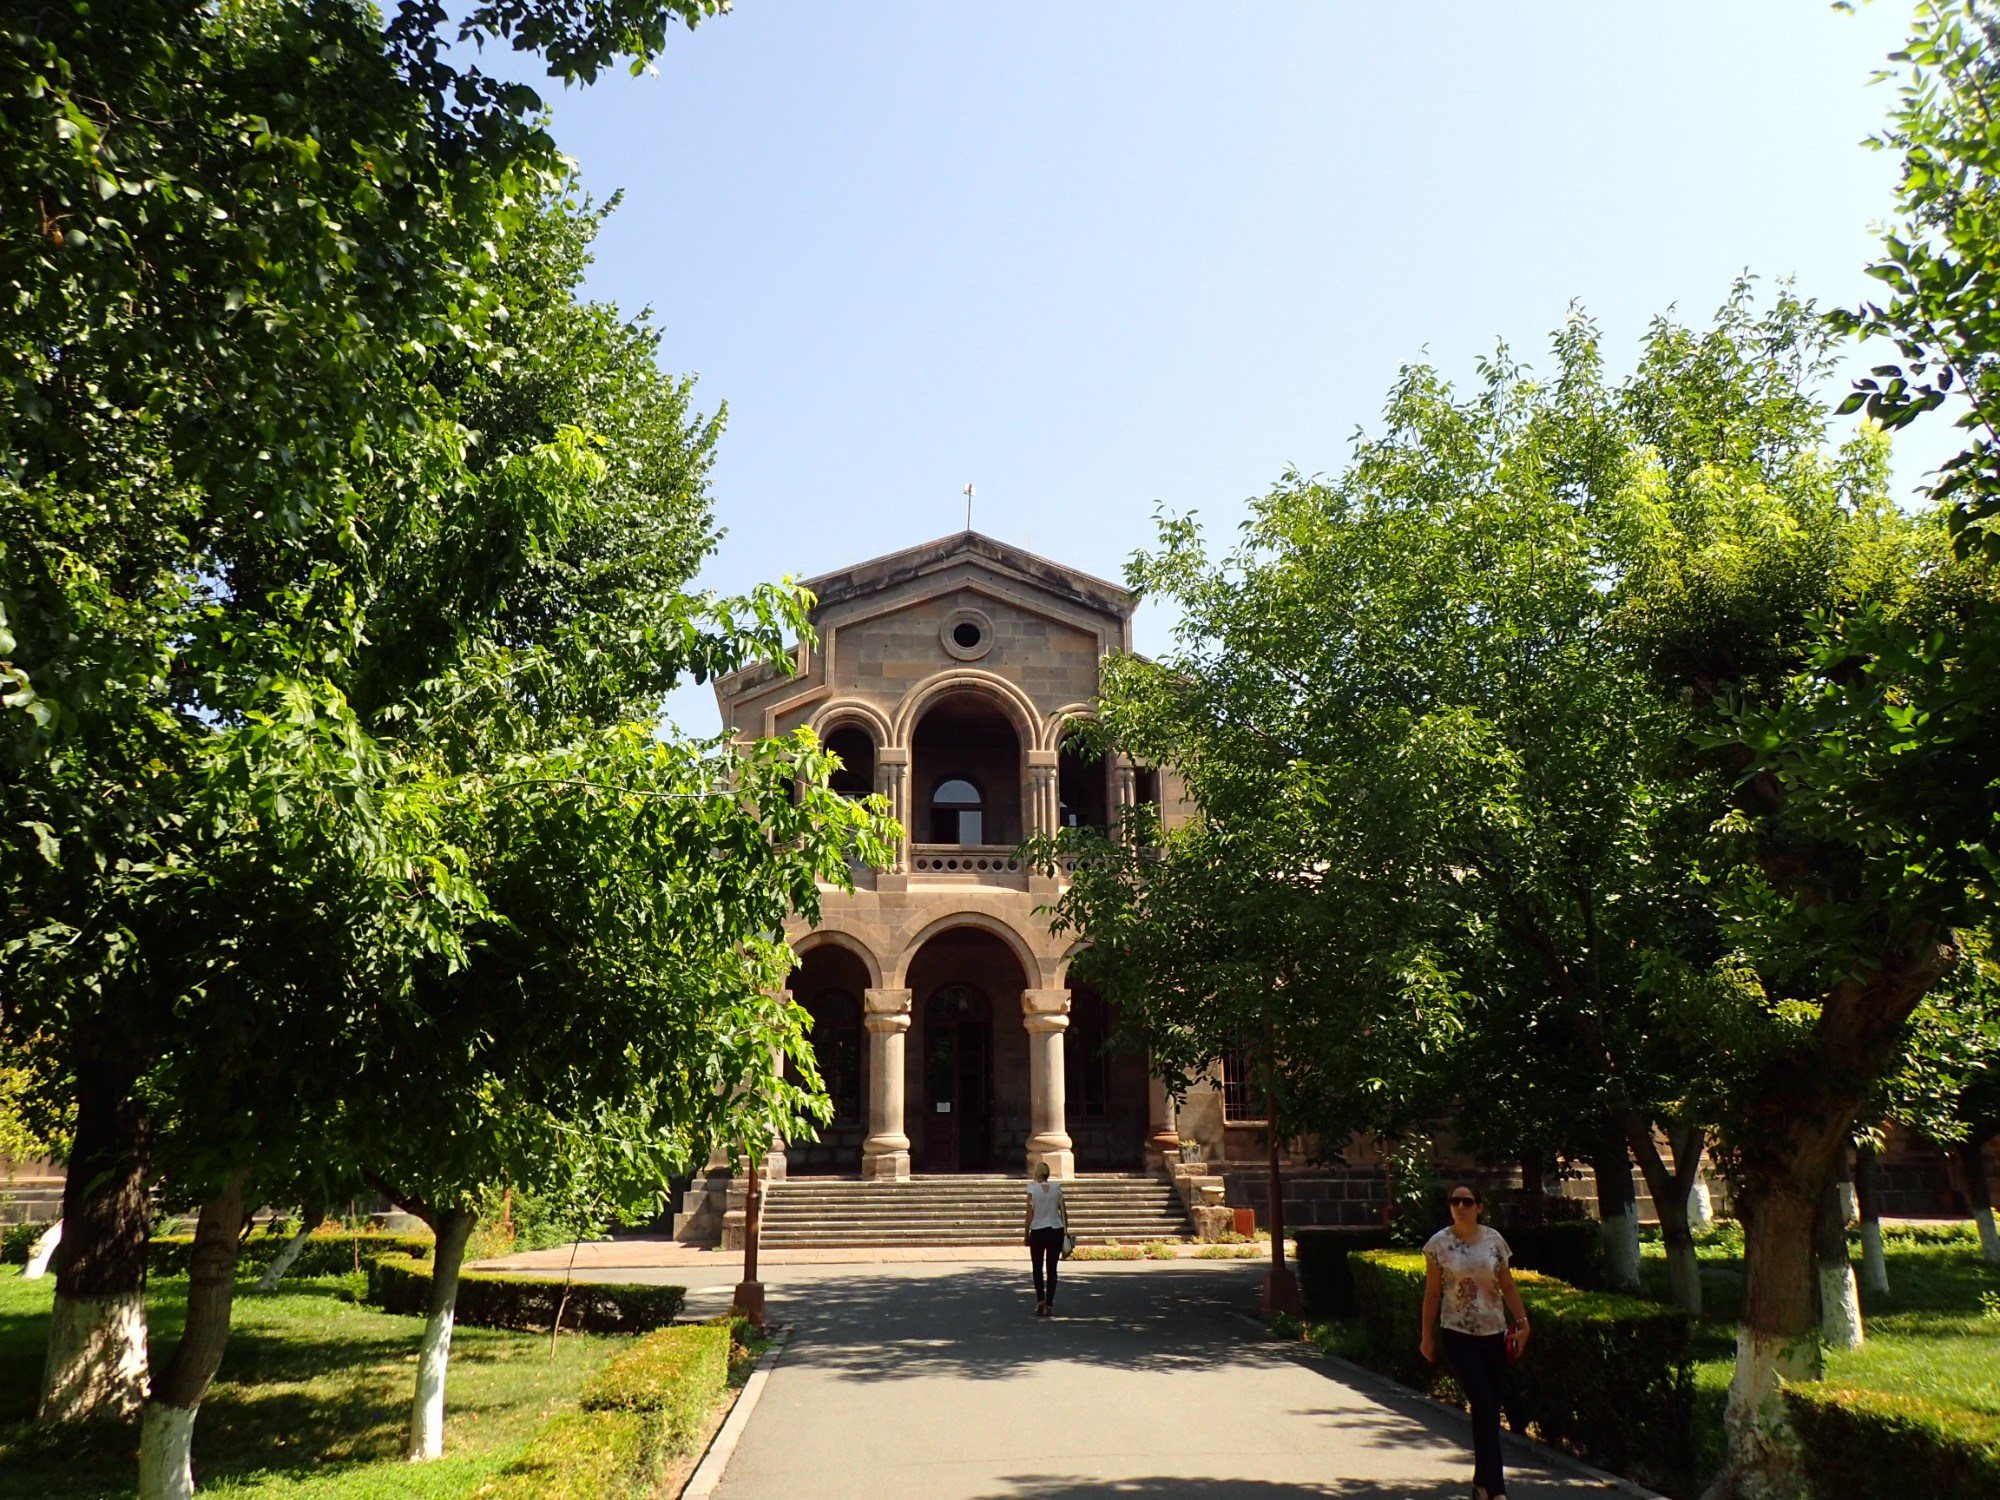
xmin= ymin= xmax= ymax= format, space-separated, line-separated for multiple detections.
xmin=1784 ymin=1382 xmax=2000 ymax=1500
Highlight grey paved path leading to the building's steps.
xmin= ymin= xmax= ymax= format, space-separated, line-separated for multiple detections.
xmin=690 ymin=1262 xmax=1642 ymax=1500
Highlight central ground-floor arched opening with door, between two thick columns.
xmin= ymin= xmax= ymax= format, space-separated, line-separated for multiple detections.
xmin=904 ymin=928 xmax=1028 ymax=1172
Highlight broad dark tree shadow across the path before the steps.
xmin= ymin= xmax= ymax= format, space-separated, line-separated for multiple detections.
xmin=774 ymin=1268 xmax=1286 ymax=1380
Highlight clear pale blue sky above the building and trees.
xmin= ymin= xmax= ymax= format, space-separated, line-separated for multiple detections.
xmin=508 ymin=0 xmax=1948 ymax=734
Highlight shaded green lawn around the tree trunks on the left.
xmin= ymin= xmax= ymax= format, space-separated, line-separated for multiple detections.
xmin=0 ymin=1266 xmax=626 ymax=1500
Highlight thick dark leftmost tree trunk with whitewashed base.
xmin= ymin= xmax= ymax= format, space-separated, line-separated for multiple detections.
xmin=36 ymin=1048 xmax=152 ymax=1426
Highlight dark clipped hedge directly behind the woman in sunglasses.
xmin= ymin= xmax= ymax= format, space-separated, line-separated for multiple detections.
xmin=1352 ymin=1250 xmax=1694 ymax=1488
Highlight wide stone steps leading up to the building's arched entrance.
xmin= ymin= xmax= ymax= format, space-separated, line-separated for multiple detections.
xmin=762 ymin=1174 xmax=1188 ymax=1250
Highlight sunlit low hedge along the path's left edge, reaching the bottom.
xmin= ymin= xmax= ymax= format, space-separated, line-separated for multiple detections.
xmin=480 ymin=1324 xmax=730 ymax=1500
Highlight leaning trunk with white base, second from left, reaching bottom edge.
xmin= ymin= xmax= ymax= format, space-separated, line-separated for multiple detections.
xmin=138 ymin=1172 xmax=250 ymax=1500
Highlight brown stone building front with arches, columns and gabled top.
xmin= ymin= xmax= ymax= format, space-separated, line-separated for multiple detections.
xmin=716 ymin=532 xmax=1220 ymax=1180
